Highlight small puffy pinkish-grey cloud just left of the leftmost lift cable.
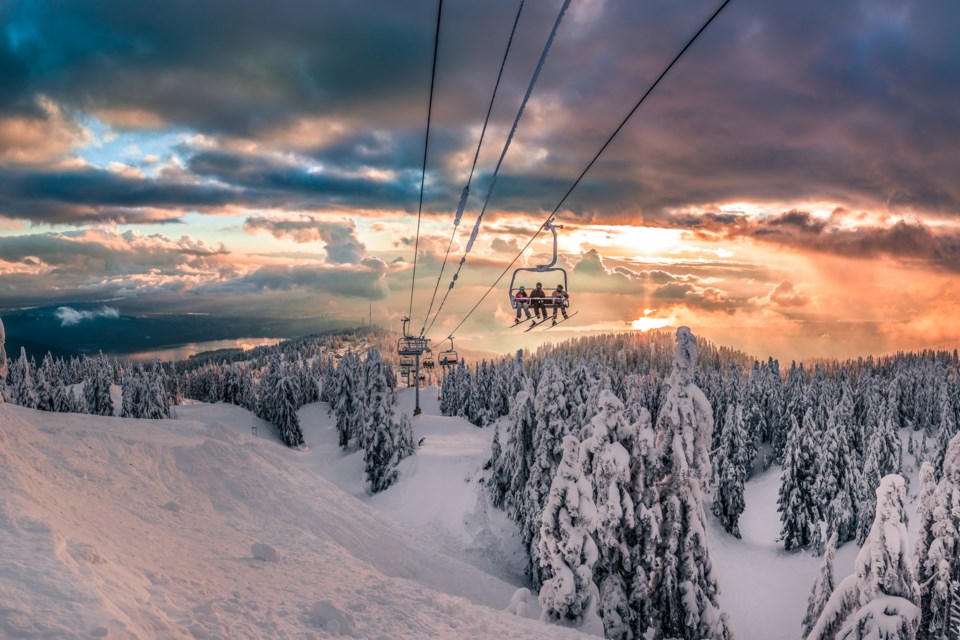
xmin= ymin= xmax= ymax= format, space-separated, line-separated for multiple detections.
xmin=243 ymin=215 xmax=367 ymax=264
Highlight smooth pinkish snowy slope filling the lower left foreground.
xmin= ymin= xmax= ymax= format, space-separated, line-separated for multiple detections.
xmin=0 ymin=405 xmax=596 ymax=639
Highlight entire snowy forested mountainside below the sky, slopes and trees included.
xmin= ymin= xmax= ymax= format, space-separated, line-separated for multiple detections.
xmin=0 ymin=328 xmax=960 ymax=640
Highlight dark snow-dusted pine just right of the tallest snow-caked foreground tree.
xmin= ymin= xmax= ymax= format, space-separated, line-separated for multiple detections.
xmin=712 ymin=405 xmax=747 ymax=538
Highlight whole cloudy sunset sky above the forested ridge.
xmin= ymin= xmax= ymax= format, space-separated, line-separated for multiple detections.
xmin=0 ymin=0 xmax=960 ymax=360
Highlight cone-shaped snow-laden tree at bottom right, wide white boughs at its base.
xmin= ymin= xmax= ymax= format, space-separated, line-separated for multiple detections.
xmin=808 ymin=475 xmax=920 ymax=640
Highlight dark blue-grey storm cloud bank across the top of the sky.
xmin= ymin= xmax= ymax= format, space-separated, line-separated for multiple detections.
xmin=0 ymin=0 xmax=960 ymax=230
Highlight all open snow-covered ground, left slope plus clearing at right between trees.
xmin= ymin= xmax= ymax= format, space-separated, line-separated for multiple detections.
xmin=0 ymin=389 xmax=928 ymax=640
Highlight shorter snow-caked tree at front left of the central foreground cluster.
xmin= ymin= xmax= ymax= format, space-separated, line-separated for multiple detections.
xmin=539 ymin=436 xmax=599 ymax=626
